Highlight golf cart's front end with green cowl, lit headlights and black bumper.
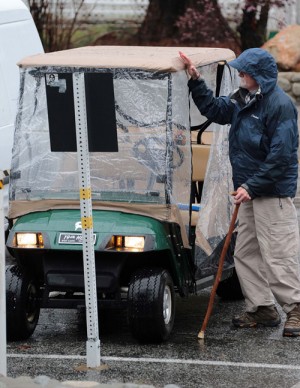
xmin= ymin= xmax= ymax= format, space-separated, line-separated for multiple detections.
xmin=7 ymin=210 xmax=195 ymax=307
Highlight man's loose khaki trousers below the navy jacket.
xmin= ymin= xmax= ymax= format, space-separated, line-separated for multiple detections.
xmin=235 ymin=198 xmax=300 ymax=313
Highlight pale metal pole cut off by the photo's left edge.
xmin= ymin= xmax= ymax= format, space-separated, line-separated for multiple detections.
xmin=0 ymin=175 xmax=7 ymax=376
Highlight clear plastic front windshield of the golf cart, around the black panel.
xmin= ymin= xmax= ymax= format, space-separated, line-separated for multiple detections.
xmin=12 ymin=68 xmax=191 ymax=204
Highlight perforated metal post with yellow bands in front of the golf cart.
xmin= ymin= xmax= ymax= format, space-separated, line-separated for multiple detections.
xmin=73 ymin=72 xmax=100 ymax=368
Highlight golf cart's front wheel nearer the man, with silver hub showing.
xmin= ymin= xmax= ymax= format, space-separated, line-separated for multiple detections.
xmin=128 ymin=268 xmax=175 ymax=342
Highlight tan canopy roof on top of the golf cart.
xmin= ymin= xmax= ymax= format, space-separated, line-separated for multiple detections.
xmin=19 ymin=46 xmax=235 ymax=72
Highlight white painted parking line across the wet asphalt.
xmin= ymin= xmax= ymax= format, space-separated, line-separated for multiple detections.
xmin=7 ymin=353 xmax=300 ymax=370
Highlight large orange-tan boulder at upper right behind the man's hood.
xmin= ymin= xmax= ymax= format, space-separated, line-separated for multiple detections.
xmin=262 ymin=25 xmax=300 ymax=71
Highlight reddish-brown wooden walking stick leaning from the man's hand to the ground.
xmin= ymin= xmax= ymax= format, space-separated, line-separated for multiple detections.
xmin=198 ymin=200 xmax=240 ymax=339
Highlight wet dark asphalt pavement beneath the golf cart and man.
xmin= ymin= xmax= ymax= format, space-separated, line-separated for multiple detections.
xmin=4 ymin=289 xmax=300 ymax=388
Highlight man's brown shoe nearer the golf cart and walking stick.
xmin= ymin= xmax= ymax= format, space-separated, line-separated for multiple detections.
xmin=232 ymin=306 xmax=282 ymax=330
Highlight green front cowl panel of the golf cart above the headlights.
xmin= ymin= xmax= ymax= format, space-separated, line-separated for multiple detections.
xmin=13 ymin=210 xmax=172 ymax=250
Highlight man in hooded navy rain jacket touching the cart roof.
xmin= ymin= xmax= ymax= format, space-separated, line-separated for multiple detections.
xmin=180 ymin=48 xmax=300 ymax=337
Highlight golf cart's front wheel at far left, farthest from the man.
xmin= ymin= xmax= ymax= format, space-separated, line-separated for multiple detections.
xmin=6 ymin=265 xmax=40 ymax=341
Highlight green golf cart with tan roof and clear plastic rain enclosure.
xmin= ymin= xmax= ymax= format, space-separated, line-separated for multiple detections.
xmin=6 ymin=46 xmax=239 ymax=341
